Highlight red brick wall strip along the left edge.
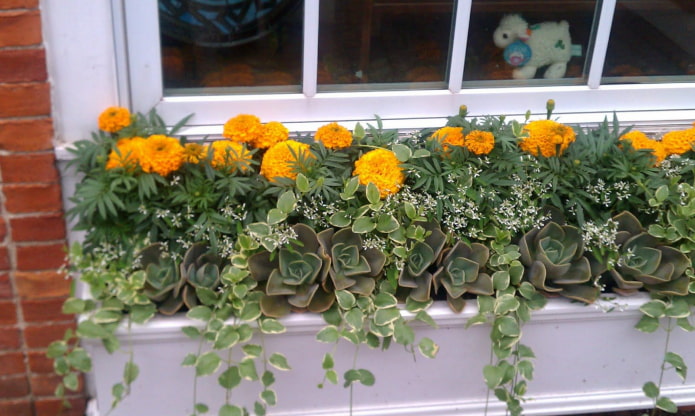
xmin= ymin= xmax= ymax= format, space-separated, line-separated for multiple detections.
xmin=0 ymin=0 xmax=85 ymax=416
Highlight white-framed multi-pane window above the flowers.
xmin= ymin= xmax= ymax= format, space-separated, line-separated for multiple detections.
xmin=47 ymin=0 xmax=695 ymax=141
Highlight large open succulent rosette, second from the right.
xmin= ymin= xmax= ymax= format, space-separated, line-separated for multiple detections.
xmin=519 ymin=221 xmax=604 ymax=303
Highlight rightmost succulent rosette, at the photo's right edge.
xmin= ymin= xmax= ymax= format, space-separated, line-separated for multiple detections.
xmin=610 ymin=211 xmax=690 ymax=296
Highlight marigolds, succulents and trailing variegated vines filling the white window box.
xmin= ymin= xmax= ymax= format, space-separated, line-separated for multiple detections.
xmin=48 ymin=100 xmax=695 ymax=416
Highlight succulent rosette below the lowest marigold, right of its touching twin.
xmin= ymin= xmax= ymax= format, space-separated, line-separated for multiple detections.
xmin=318 ymin=228 xmax=386 ymax=296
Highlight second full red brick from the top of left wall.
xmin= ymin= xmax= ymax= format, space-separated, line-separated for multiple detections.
xmin=0 ymin=48 xmax=46 ymax=82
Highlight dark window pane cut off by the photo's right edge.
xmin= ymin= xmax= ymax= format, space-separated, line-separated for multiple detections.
xmin=603 ymin=0 xmax=695 ymax=83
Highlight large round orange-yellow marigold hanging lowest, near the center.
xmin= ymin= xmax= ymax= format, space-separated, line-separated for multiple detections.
xmin=352 ymin=149 xmax=405 ymax=198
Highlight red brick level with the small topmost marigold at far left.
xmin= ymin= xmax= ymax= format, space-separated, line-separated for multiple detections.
xmin=0 ymin=118 xmax=53 ymax=152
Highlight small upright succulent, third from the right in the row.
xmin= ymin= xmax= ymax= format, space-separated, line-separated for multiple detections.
xmin=432 ymin=241 xmax=494 ymax=312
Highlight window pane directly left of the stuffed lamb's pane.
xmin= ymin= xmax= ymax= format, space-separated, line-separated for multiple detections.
xmin=318 ymin=0 xmax=455 ymax=91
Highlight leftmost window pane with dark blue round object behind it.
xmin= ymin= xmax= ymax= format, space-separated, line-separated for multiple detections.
xmin=159 ymin=0 xmax=303 ymax=95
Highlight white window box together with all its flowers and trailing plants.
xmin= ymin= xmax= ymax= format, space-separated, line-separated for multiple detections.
xmin=53 ymin=100 xmax=695 ymax=416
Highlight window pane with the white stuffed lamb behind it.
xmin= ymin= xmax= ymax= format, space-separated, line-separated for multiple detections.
xmin=463 ymin=0 xmax=597 ymax=86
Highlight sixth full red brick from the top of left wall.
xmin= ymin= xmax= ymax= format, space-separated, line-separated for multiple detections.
xmin=3 ymin=182 xmax=62 ymax=214
